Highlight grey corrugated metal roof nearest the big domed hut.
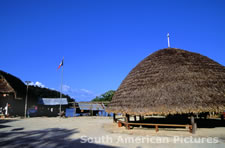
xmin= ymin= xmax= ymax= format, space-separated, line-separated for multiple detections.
xmin=78 ymin=103 xmax=105 ymax=110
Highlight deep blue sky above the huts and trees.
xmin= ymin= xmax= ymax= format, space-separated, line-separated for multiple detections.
xmin=0 ymin=0 xmax=225 ymax=101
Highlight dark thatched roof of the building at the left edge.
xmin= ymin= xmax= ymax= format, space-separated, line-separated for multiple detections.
xmin=0 ymin=70 xmax=26 ymax=99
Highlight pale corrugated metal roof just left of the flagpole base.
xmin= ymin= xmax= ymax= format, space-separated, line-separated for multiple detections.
xmin=38 ymin=98 xmax=68 ymax=105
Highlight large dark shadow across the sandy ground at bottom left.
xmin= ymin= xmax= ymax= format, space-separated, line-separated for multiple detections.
xmin=0 ymin=128 xmax=118 ymax=148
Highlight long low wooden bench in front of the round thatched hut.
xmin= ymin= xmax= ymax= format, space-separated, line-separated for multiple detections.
xmin=117 ymin=120 xmax=192 ymax=133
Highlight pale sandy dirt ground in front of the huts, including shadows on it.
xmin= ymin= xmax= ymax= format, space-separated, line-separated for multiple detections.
xmin=0 ymin=117 xmax=225 ymax=148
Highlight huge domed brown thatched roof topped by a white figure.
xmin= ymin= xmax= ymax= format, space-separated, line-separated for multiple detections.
xmin=107 ymin=48 xmax=225 ymax=115
